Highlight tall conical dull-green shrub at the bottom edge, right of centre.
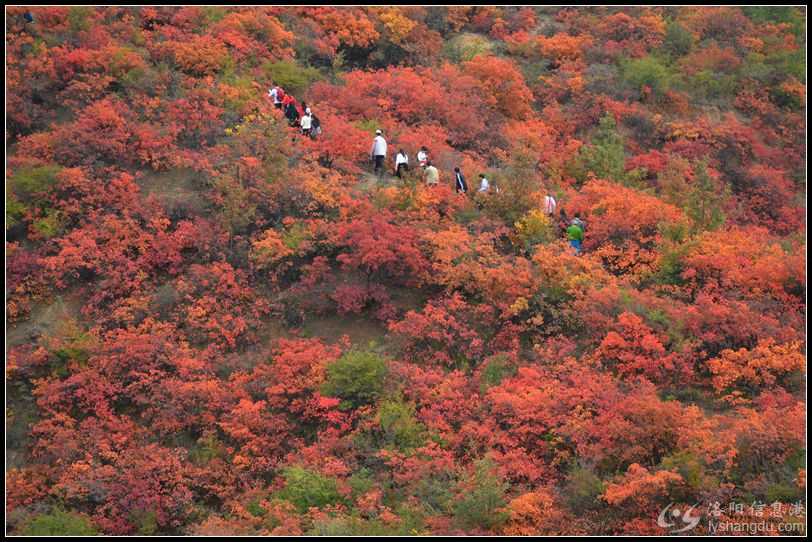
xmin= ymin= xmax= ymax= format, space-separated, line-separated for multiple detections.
xmin=452 ymin=460 xmax=508 ymax=530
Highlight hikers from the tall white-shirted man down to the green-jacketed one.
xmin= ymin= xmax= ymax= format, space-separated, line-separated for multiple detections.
xmin=369 ymin=130 xmax=586 ymax=254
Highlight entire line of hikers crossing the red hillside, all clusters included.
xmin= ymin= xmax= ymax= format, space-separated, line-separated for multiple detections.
xmin=268 ymin=87 xmax=586 ymax=254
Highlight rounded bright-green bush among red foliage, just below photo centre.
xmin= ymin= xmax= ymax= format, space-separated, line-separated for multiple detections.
xmin=321 ymin=350 xmax=387 ymax=409
